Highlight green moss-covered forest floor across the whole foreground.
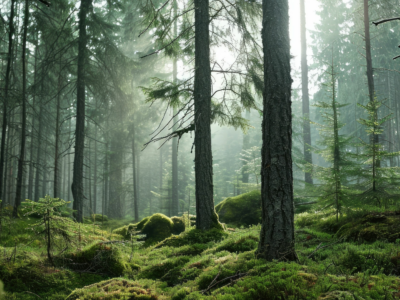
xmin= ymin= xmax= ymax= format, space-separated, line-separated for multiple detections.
xmin=0 ymin=207 xmax=400 ymax=300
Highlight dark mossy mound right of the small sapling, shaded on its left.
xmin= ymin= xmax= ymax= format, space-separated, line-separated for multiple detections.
xmin=59 ymin=243 xmax=139 ymax=276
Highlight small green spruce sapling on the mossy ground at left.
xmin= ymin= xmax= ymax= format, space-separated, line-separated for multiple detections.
xmin=25 ymin=195 xmax=71 ymax=264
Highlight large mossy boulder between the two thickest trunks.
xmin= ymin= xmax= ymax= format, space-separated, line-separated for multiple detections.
xmin=215 ymin=190 xmax=261 ymax=227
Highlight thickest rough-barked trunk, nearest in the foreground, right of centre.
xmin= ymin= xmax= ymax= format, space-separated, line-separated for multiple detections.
xmin=257 ymin=0 xmax=296 ymax=260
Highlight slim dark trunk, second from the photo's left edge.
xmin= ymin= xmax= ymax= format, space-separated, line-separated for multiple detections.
xmin=13 ymin=0 xmax=29 ymax=218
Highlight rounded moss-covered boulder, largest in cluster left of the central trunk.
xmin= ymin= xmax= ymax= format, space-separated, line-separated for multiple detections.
xmin=141 ymin=213 xmax=174 ymax=245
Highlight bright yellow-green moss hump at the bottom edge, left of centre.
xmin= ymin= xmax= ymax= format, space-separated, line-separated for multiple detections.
xmin=66 ymin=278 xmax=158 ymax=300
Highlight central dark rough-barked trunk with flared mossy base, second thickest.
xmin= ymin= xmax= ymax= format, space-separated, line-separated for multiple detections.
xmin=194 ymin=0 xmax=221 ymax=230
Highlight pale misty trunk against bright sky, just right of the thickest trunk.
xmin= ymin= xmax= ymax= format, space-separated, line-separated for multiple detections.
xmin=300 ymin=0 xmax=313 ymax=184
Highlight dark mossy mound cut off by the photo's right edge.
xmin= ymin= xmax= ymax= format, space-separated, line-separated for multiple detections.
xmin=336 ymin=213 xmax=400 ymax=242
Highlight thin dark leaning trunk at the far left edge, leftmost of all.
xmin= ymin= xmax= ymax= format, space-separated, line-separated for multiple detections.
xmin=0 ymin=0 xmax=16 ymax=201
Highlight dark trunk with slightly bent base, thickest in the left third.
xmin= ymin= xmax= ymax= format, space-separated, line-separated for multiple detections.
xmin=71 ymin=0 xmax=91 ymax=222
